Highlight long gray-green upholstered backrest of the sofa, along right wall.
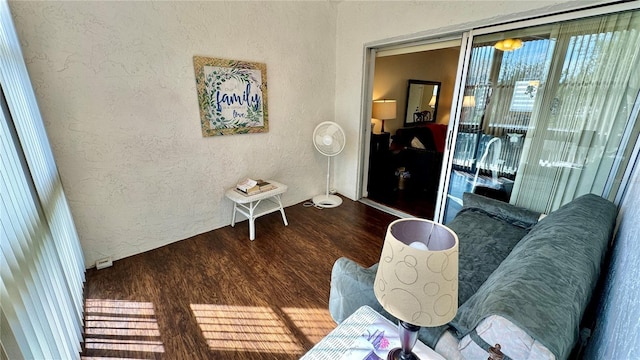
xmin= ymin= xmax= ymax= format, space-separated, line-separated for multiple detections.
xmin=451 ymin=194 xmax=617 ymax=359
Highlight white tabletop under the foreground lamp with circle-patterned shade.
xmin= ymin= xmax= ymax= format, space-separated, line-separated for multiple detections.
xmin=300 ymin=306 xmax=445 ymax=360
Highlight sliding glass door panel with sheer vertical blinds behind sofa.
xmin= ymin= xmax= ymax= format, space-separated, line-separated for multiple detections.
xmin=440 ymin=7 xmax=640 ymax=223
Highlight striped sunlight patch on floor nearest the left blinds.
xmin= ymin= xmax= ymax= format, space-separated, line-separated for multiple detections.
xmin=83 ymin=299 xmax=164 ymax=354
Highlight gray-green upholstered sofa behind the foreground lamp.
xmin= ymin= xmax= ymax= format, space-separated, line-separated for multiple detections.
xmin=329 ymin=193 xmax=617 ymax=359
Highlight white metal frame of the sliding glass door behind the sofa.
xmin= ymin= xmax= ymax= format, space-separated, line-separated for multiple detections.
xmin=434 ymin=1 xmax=640 ymax=223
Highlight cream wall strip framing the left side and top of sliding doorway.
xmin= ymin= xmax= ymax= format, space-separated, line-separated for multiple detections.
xmin=334 ymin=0 xmax=611 ymax=199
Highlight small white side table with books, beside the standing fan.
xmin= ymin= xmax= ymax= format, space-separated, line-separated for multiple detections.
xmin=225 ymin=180 xmax=289 ymax=240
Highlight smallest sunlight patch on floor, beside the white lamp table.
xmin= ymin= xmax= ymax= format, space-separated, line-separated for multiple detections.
xmin=282 ymin=308 xmax=336 ymax=344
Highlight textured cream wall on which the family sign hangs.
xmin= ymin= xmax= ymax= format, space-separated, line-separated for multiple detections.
xmin=10 ymin=1 xmax=336 ymax=267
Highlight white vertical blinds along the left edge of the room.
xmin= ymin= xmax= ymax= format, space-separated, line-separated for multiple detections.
xmin=0 ymin=0 xmax=84 ymax=359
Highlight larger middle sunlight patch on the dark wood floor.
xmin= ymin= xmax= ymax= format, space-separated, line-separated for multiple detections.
xmin=191 ymin=304 xmax=303 ymax=354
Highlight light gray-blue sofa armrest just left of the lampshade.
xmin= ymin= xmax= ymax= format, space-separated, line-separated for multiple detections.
xmin=329 ymin=257 xmax=383 ymax=323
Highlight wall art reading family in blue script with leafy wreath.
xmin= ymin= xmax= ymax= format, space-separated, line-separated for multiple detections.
xmin=193 ymin=56 xmax=269 ymax=137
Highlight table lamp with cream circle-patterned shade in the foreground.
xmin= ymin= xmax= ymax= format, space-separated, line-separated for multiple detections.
xmin=374 ymin=218 xmax=458 ymax=360
